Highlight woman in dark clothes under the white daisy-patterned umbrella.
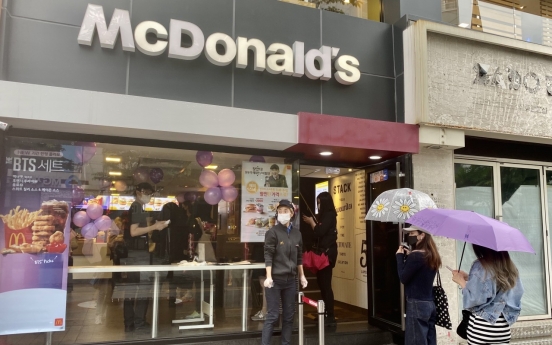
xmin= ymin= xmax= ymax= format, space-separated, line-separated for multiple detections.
xmin=396 ymin=227 xmax=441 ymax=345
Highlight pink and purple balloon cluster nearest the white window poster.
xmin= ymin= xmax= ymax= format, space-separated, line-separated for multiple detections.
xmin=196 ymin=151 xmax=238 ymax=205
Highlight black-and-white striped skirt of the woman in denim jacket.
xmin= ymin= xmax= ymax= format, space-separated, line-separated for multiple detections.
xmin=468 ymin=314 xmax=512 ymax=345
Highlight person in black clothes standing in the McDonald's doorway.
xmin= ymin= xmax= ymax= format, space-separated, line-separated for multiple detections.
xmin=303 ymin=192 xmax=337 ymax=326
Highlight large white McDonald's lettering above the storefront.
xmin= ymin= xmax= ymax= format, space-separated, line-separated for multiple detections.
xmin=78 ymin=4 xmax=360 ymax=85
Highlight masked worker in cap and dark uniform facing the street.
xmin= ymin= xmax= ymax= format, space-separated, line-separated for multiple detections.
xmin=262 ymin=200 xmax=307 ymax=345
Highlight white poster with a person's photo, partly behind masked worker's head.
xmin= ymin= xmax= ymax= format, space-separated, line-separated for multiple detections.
xmin=240 ymin=162 xmax=292 ymax=242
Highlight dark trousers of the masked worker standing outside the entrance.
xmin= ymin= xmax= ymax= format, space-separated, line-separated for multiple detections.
xmin=262 ymin=278 xmax=297 ymax=345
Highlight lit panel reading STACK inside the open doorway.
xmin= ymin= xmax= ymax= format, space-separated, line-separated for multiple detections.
xmin=330 ymin=174 xmax=355 ymax=280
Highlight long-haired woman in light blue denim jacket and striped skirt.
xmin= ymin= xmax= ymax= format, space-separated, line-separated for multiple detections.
xmin=452 ymin=244 xmax=524 ymax=344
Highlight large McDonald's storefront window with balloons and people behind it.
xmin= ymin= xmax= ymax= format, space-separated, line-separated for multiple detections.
xmin=0 ymin=138 xmax=299 ymax=344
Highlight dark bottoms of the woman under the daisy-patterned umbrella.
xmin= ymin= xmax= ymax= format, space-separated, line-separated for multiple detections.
xmin=404 ymin=298 xmax=437 ymax=345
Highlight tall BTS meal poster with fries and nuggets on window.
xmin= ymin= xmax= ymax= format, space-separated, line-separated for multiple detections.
xmin=0 ymin=141 xmax=84 ymax=335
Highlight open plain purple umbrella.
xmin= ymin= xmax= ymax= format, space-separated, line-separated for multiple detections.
xmin=408 ymin=209 xmax=535 ymax=264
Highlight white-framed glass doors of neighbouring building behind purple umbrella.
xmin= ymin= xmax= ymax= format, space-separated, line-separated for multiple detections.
xmin=454 ymin=160 xmax=552 ymax=320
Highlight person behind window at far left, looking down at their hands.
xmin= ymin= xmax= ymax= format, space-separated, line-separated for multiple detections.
xmin=121 ymin=182 xmax=168 ymax=332
